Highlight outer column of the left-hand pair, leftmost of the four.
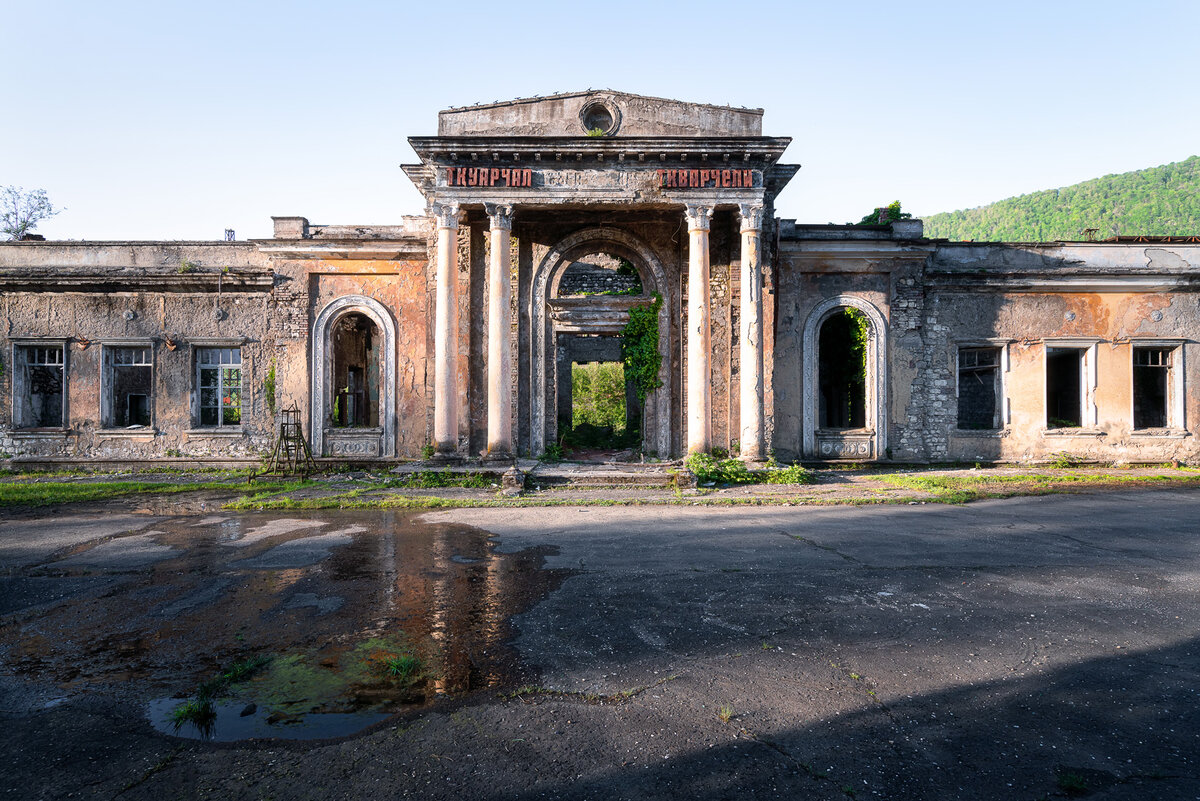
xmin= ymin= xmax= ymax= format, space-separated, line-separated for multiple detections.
xmin=431 ymin=203 xmax=460 ymax=456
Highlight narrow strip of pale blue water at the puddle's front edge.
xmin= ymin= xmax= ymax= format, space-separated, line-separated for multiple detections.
xmin=146 ymin=698 xmax=391 ymax=742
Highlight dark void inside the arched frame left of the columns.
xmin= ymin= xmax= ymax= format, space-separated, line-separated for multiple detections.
xmin=329 ymin=312 xmax=380 ymax=428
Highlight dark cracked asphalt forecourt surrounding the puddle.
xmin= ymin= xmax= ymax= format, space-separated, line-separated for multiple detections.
xmin=0 ymin=489 xmax=1200 ymax=801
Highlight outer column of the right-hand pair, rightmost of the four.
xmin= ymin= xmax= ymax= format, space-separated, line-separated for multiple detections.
xmin=738 ymin=203 xmax=764 ymax=462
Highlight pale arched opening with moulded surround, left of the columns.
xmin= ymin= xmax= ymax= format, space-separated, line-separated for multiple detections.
xmin=312 ymin=295 xmax=396 ymax=457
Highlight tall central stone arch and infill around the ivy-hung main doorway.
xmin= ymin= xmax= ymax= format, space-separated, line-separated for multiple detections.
xmin=529 ymin=228 xmax=673 ymax=454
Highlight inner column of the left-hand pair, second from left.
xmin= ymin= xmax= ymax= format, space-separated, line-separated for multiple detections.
xmin=484 ymin=203 xmax=512 ymax=459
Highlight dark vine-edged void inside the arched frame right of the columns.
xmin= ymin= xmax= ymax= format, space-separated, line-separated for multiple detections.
xmin=817 ymin=308 xmax=871 ymax=428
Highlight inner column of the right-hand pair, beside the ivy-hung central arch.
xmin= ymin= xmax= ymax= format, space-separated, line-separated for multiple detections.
xmin=686 ymin=204 xmax=713 ymax=453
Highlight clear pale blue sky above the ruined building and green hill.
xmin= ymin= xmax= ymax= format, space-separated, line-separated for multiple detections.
xmin=0 ymin=0 xmax=1200 ymax=239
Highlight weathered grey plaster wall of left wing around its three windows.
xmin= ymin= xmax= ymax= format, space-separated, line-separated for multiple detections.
xmin=0 ymin=242 xmax=275 ymax=459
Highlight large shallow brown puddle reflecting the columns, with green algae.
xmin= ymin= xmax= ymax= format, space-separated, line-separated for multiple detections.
xmin=0 ymin=512 xmax=570 ymax=741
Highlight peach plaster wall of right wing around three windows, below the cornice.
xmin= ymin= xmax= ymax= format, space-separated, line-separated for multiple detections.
xmin=929 ymin=291 xmax=1200 ymax=462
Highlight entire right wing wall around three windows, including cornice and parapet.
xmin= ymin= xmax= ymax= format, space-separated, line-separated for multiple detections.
xmin=925 ymin=243 xmax=1200 ymax=462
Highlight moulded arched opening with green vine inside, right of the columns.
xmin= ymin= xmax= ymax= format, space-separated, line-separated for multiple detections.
xmin=804 ymin=295 xmax=887 ymax=459
